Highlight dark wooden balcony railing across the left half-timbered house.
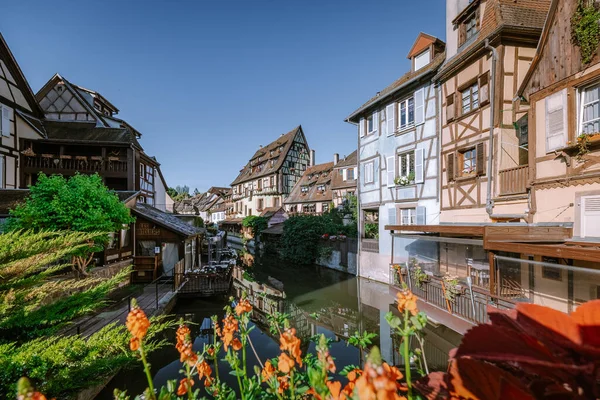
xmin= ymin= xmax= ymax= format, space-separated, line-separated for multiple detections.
xmin=24 ymin=154 xmax=128 ymax=173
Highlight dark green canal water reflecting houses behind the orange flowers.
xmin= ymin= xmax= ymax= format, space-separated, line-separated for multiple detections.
xmin=97 ymin=255 xmax=461 ymax=400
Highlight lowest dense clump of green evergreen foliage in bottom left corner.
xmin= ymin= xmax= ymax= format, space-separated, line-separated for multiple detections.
xmin=0 ymin=317 xmax=174 ymax=399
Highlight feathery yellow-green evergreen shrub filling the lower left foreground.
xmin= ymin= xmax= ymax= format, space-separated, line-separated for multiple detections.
xmin=0 ymin=231 xmax=175 ymax=399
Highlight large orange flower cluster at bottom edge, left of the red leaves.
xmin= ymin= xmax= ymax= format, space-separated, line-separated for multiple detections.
xmin=355 ymin=361 xmax=406 ymax=400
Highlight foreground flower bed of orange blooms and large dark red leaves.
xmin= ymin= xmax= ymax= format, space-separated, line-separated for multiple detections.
xmin=19 ymin=290 xmax=600 ymax=400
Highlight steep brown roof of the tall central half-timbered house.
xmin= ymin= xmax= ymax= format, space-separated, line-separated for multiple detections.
xmin=231 ymin=125 xmax=308 ymax=186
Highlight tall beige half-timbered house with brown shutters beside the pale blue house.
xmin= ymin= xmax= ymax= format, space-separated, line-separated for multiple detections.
xmin=435 ymin=0 xmax=549 ymax=223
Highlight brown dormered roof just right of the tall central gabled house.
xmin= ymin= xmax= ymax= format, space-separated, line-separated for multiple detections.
xmin=284 ymin=162 xmax=333 ymax=204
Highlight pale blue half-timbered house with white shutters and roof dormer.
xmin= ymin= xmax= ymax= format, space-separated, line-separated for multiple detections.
xmin=347 ymin=33 xmax=445 ymax=282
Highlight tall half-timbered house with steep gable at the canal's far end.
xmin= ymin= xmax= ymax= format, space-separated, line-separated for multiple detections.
xmin=231 ymin=126 xmax=314 ymax=218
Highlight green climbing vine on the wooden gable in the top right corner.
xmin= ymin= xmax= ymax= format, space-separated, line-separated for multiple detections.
xmin=571 ymin=0 xmax=600 ymax=64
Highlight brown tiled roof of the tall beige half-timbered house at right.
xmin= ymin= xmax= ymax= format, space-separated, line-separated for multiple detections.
xmin=434 ymin=0 xmax=551 ymax=80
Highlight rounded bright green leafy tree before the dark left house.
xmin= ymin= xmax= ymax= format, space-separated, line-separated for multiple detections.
xmin=6 ymin=174 xmax=135 ymax=276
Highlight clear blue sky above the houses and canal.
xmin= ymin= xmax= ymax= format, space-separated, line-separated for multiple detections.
xmin=0 ymin=0 xmax=445 ymax=191
